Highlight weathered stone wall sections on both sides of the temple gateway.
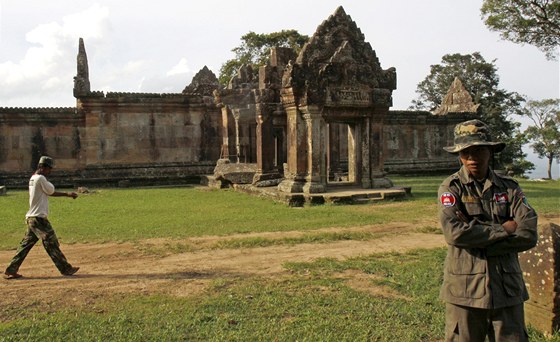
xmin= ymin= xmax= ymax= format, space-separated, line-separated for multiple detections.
xmin=0 ymin=103 xmax=473 ymax=187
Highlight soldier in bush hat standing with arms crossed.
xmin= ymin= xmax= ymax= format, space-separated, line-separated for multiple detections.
xmin=438 ymin=120 xmax=537 ymax=341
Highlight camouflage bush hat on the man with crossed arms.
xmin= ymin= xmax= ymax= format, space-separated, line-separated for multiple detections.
xmin=443 ymin=120 xmax=506 ymax=153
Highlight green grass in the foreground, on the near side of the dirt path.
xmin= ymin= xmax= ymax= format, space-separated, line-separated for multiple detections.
xmin=0 ymin=248 xmax=560 ymax=342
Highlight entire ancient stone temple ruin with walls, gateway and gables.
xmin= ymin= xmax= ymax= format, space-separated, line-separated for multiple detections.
xmin=0 ymin=7 xmax=477 ymax=203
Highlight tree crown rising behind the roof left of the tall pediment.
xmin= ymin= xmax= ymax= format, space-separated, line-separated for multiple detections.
xmin=219 ymin=30 xmax=309 ymax=86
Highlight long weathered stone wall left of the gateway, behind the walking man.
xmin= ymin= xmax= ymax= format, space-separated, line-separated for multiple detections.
xmin=0 ymin=92 xmax=221 ymax=187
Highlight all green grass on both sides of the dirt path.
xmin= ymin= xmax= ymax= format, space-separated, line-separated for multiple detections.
xmin=0 ymin=177 xmax=560 ymax=341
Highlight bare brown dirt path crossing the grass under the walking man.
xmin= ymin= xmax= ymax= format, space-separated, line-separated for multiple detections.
xmin=0 ymin=218 xmax=558 ymax=321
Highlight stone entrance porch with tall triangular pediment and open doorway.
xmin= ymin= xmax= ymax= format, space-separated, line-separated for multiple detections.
xmin=279 ymin=7 xmax=396 ymax=193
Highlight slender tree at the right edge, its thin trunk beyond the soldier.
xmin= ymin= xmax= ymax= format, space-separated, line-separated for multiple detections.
xmin=522 ymin=99 xmax=560 ymax=178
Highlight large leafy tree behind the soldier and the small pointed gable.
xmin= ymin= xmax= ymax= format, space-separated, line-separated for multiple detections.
xmin=410 ymin=52 xmax=534 ymax=175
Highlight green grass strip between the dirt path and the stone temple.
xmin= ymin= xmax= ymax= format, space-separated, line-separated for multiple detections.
xmin=0 ymin=177 xmax=560 ymax=250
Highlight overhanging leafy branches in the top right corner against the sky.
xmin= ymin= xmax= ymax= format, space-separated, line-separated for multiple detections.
xmin=480 ymin=0 xmax=560 ymax=60
